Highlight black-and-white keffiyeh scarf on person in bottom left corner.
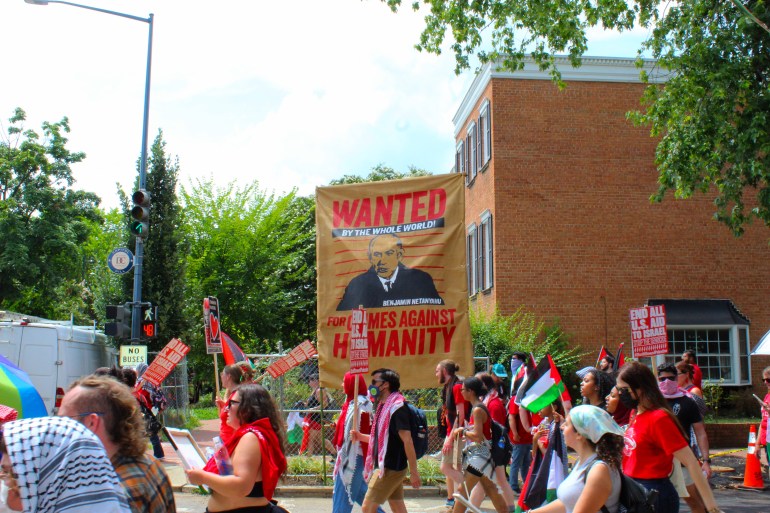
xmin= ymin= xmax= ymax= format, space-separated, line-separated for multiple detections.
xmin=2 ymin=417 xmax=130 ymax=513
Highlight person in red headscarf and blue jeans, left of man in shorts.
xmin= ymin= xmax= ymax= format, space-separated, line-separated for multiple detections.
xmin=332 ymin=372 xmax=384 ymax=513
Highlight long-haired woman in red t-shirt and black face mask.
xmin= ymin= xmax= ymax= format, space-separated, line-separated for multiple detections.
xmin=616 ymin=362 xmax=721 ymax=513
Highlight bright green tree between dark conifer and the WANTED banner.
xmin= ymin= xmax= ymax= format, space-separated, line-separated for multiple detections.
xmin=182 ymin=180 xmax=316 ymax=370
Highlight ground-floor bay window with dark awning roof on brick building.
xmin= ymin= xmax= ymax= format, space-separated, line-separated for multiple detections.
xmin=648 ymin=299 xmax=751 ymax=385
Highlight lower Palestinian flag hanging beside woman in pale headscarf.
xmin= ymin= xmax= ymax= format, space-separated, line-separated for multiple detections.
xmin=519 ymin=422 xmax=567 ymax=509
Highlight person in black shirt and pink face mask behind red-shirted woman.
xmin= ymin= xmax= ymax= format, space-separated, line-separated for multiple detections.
xmin=658 ymin=364 xmax=711 ymax=513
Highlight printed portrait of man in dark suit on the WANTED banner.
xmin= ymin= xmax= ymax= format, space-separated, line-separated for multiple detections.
xmin=337 ymin=234 xmax=444 ymax=311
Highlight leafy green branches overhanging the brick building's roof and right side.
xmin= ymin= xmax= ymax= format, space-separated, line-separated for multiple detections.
xmin=382 ymin=0 xmax=770 ymax=235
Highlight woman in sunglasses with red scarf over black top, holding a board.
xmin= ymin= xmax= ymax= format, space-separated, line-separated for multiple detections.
xmin=187 ymin=384 xmax=286 ymax=513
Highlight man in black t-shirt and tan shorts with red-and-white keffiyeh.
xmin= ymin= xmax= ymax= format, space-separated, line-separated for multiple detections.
xmin=350 ymin=369 xmax=420 ymax=513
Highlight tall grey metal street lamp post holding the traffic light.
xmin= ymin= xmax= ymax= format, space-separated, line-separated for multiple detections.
xmin=24 ymin=0 xmax=154 ymax=343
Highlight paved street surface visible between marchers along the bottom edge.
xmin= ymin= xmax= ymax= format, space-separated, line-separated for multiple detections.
xmin=171 ymin=490 xmax=770 ymax=513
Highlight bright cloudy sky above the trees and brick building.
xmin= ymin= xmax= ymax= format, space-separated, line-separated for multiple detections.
xmin=0 ymin=0 xmax=645 ymax=208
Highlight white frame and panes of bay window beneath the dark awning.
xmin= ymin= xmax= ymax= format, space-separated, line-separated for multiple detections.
xmin=655 ymin=324 xmax=751 ymax=386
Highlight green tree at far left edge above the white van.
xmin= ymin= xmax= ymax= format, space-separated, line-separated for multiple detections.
xmin=0 ymin=108 xmax=102 ymax=321
